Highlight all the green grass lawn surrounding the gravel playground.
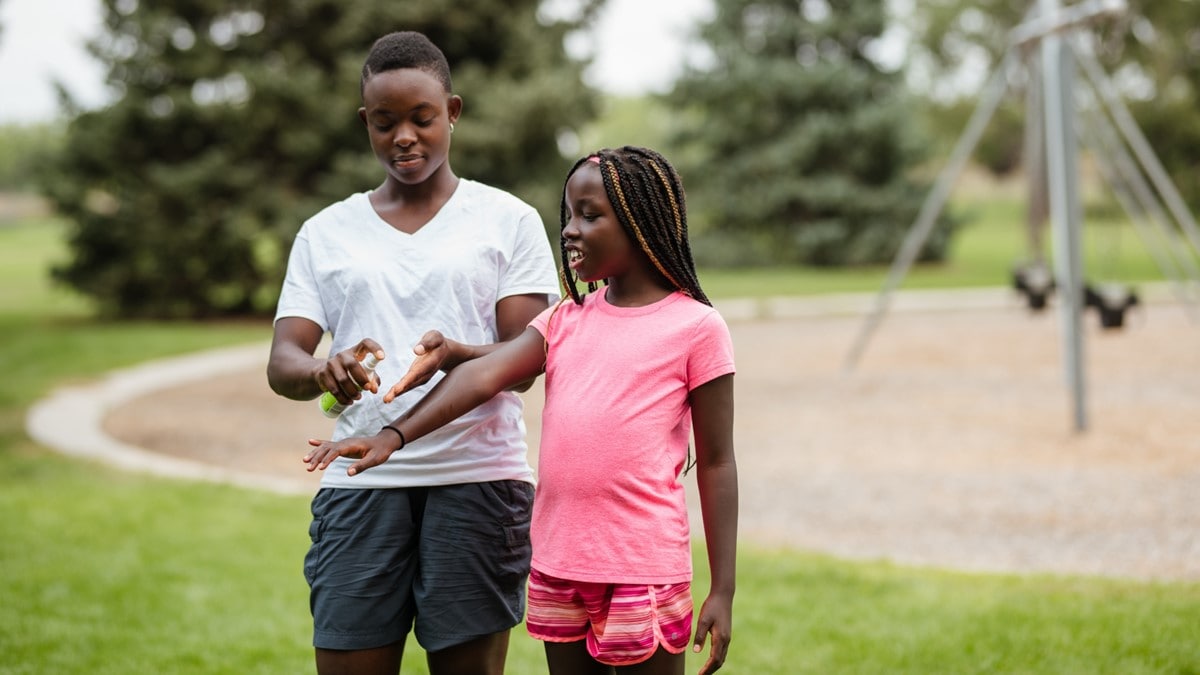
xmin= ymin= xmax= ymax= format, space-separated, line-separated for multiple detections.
xmin=0 ymin=203 xmax=1200 ymax=675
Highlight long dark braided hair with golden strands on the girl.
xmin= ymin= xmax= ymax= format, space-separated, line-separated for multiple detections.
xmin=559 ymin=145 xmax=713 ymax=305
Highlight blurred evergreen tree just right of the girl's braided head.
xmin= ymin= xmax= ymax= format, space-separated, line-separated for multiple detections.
xmin=670 ymin=0 xmax=948 ymax=265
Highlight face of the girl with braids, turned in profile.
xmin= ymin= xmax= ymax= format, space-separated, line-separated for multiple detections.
xmin=563 ymin=161 xmax=641 ymax=281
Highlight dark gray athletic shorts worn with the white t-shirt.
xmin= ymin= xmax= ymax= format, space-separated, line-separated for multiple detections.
xmin=304 ymin=480 xmax=533 ymax=652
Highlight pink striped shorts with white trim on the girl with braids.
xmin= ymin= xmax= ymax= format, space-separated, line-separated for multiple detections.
xmin=526 ymin=569 xmax=692 ymax=665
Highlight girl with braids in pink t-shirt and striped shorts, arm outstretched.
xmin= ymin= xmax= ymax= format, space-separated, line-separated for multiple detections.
xmin=305 ymin=147 xmax=738 ymax=675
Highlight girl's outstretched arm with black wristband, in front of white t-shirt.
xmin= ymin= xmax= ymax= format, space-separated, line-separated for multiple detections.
xmin=304 ymin=328 xmax=546 ymax=476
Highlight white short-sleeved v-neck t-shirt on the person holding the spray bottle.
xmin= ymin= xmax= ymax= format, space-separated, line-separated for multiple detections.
xmin=275 ymin=179 xmax=559 ymax=488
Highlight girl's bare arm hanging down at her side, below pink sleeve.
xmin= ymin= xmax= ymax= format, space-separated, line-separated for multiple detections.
xmin=690 ymin=375 xmax=738 ymax=675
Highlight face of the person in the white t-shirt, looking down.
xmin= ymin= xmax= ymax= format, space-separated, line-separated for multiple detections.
xmin=359 ymin=68 xmax=462 ymax=185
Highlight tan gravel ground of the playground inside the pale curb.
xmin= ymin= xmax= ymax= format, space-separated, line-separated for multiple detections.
xmin=103 ymin=296 xmax=1200 ymax=580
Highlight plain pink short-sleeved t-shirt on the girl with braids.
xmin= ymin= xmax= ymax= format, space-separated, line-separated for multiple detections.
xmin=530 ymin=289 xmax=733 ymax=584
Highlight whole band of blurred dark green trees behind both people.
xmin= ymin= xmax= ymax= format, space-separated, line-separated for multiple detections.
xmin=0 ymin=0 xmax=1200 ymax=317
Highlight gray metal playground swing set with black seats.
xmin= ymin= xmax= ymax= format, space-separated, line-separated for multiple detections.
xmin=845 ymin=0 xmax=1200 ymax=431
